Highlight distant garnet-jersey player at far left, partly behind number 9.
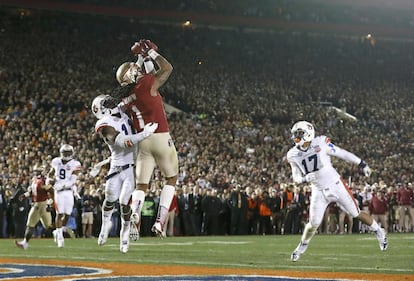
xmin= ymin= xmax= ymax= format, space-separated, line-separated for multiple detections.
xmin=15 ymin=164 xmax=53 ymax=250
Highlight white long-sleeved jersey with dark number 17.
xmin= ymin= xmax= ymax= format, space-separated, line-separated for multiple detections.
xmin=287 ymin=136 xmax=361 ymax=188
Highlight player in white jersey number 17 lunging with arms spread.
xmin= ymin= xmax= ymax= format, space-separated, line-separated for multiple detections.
xmin=287 ymin=121 xmax=388 ymax=261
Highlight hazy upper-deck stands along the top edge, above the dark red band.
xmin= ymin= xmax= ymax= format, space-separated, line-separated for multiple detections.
xmin=68 ymin=0 xmax=414 ymax=27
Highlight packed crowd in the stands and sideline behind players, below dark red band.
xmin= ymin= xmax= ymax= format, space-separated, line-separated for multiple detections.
xmin=0 ymin=7 xmax=414 ymax=237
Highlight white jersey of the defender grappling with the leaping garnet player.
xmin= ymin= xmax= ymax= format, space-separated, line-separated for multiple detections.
xmin=95 ymin=112 xmax=136 ymax=166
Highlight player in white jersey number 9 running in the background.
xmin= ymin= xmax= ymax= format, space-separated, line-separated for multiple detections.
xmin=46 ymin=144 xmax=81 ymax=248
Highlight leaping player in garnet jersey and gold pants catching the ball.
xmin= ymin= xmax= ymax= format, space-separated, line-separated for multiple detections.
xmin=116 ymin=39 xmax=178 ymax=238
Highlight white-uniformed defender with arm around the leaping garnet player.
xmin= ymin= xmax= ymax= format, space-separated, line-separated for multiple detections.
xmin=92 ymin=95 xmax=158 ymax=253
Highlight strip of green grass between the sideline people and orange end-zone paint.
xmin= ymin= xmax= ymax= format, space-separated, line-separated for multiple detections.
xmin=0 ymin=234 xmax=414 ymax=275
